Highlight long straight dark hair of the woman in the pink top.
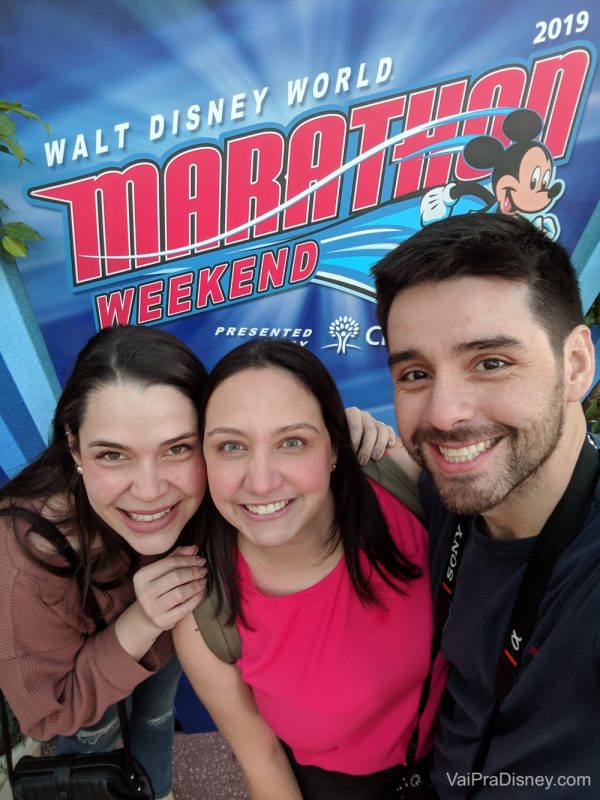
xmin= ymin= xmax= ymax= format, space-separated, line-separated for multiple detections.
xmin=201 ymin=339 xmax=421 ymax=621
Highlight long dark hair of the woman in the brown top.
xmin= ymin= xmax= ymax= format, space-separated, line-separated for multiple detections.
xmin=0 ymin=325 xmax=207 ymax=599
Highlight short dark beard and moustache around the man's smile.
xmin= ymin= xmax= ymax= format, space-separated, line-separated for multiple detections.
xmin=406 ymin=382 xmax=566 ymax=516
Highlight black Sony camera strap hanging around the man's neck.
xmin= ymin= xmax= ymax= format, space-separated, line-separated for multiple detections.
xmin=436 ymin=436 xmax=600 ymax=797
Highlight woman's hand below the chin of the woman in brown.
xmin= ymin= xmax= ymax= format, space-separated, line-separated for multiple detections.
xmin=116 ymin=545 xmax=206 ymax=661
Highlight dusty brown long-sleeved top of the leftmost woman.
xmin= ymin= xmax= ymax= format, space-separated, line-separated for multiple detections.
xmin=0 ymin=504 xmax=173 ymax=739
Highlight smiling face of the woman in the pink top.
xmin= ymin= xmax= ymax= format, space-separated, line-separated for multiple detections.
xmin=204 ymin=368 xmax=335 ymax=550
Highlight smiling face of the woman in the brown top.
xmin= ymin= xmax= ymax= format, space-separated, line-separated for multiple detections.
xmin=72 ymin=382 xmax=206 ymax=555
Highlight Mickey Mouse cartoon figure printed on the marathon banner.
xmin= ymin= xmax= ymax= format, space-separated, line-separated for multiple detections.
xmin=420 ymin=108 xmax=565 ymax=239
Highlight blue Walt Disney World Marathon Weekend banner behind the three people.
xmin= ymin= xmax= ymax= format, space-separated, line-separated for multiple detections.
xmin=0 ymin=0 xmax=600 ymax=482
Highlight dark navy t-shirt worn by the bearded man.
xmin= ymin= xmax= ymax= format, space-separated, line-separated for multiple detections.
xmin=421 ymin=460 xmax=600 ymax=800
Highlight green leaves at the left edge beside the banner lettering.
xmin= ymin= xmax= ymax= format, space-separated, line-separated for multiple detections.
xmin=0 ymin=100 xmax=50 ymax=256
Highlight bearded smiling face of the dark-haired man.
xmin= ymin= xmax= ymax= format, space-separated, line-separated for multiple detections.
xmin=388 ymin=278 xmax=566 ymax=515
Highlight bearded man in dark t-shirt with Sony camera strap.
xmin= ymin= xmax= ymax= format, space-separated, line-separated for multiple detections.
xmin=374 ymin=214 xmax=600 ymax=800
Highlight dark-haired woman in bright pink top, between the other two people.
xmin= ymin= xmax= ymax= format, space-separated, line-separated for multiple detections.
xmin=174 ymin=340 xmax=443 ymax=800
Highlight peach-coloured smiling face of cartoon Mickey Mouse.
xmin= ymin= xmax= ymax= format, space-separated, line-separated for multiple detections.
xmin=495 ymin=147 xmax=552 ymax=214
